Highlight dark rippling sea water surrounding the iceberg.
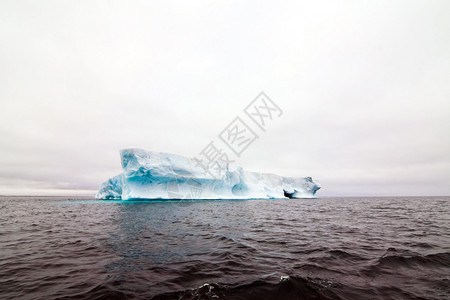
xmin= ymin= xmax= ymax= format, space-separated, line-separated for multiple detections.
xmin=0 ymin=197 xmax=450 ymax=299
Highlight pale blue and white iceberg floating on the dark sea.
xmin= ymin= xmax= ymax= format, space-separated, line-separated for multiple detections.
xmin=95 ymin=148 xmax=320 ymax=200
